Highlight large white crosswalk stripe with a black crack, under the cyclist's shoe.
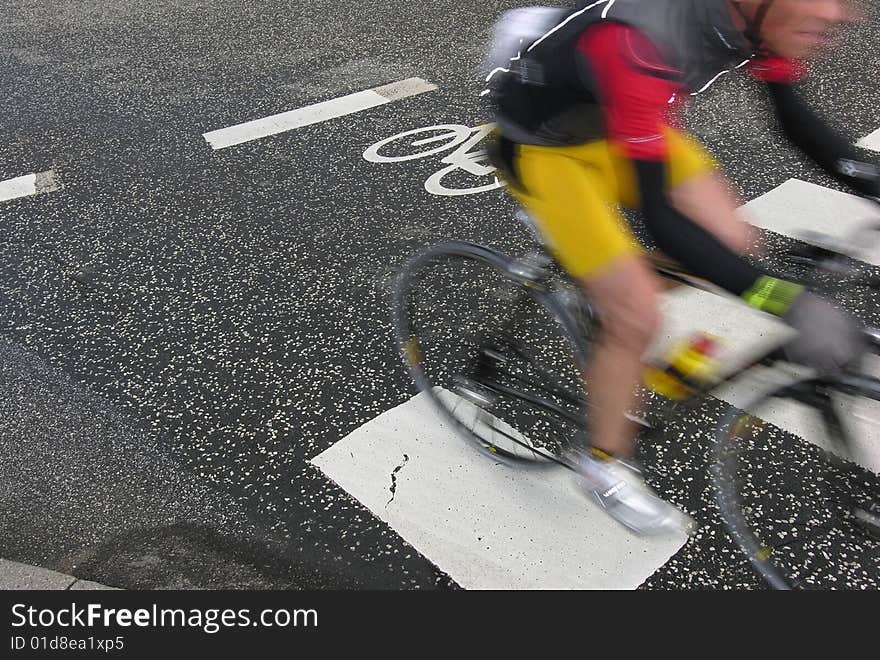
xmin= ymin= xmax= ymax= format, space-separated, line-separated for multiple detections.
xmin=312 ymin=394 xmax=686 ymax=589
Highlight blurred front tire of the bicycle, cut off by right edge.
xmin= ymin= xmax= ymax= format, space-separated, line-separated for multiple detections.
xmin=710 ymin=374 xmax=880 ymax=590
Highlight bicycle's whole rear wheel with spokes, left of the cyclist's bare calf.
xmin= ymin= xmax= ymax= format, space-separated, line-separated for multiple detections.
xmin=393 ymin=241 xmax=586 ymax=466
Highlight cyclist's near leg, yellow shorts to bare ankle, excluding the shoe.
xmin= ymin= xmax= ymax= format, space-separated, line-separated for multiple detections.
xmin=512 ymin=142 xmax=659 ymax=455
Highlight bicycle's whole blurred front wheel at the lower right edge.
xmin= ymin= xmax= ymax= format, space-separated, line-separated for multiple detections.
xmin=712 ymin=375 xmax=880 ymax=589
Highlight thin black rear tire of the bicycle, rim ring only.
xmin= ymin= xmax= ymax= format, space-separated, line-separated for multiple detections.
xmin=392 ymin=241 xmax=587 ymax=466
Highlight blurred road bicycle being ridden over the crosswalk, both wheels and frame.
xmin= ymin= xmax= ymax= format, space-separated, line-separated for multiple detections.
xmin=392 ymin=208 xmax=880 ymax=589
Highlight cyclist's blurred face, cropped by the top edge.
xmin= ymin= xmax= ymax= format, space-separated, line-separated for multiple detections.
xmin=728 ymin=0 xmax=858 ymax=59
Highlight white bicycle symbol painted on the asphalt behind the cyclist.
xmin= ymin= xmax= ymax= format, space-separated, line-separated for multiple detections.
xmin=364 ymin=124 xmax=504 ymax=195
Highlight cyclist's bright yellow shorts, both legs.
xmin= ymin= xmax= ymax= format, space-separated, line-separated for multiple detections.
xmin=508 ymin=128 xmax=716 ymax=277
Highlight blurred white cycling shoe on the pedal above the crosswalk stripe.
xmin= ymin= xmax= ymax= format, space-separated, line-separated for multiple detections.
xmin=568 ymin=451 xmax=695 ymax=536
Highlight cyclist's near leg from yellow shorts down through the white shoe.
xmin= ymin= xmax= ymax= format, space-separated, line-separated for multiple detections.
xmin=512 ymin=141 xmax=687 ymax=534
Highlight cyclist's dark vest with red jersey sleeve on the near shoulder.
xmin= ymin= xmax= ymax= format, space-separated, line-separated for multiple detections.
xmin=488 ymin=0 xmax=794 ymax=147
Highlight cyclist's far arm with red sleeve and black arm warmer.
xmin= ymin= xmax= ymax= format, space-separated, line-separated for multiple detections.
xmin=748 ymin=57 xmax=880 ymax=197
